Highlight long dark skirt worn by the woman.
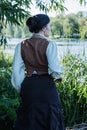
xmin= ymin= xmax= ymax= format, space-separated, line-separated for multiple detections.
xmin=14 ymin=75 xmax=65 ymax=130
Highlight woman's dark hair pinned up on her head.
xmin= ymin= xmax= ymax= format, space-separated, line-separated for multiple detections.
xmin=26 ymin=14 xmax=50 ymax=33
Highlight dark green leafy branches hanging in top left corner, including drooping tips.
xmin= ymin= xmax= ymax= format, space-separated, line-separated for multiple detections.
xmin=0 ymin=0 xmax=31 ymax=45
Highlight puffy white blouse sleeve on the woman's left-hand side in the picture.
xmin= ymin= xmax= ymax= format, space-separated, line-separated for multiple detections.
xmin=11 ymin=43 xmax=25 ymax=91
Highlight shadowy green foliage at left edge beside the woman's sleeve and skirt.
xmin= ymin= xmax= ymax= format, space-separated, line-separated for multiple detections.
xmin=0 ymin=53 xmax=19 ymax=130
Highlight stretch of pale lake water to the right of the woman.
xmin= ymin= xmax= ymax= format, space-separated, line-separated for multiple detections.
xmin=57 ymin=41 xmax=87 ymax=59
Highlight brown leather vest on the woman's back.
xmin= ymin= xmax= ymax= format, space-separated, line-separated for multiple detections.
xmin=21 ymin=37 xmax=49 ymax=76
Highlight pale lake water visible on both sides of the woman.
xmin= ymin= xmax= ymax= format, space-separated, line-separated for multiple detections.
xmin=1 ymin=38 xmax=87 ymax=60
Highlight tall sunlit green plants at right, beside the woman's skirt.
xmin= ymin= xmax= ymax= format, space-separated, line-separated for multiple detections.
xmin=57 ymin=54 xmax=87 ymax=126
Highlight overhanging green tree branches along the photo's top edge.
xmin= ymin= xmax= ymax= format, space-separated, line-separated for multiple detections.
xmin=0 ymin=0 xmax=86 ymax=24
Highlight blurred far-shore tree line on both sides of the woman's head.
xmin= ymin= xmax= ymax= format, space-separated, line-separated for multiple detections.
xmin=2 ymin=11 xmax=87 ymax=39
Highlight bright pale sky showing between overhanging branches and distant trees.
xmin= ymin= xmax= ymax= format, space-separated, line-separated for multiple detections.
xmin=31 ymin=0 xmax=87 ymax=16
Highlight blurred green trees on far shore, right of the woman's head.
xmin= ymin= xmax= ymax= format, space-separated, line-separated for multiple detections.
xmin=51 ymin=11 xmax=87 ymax=39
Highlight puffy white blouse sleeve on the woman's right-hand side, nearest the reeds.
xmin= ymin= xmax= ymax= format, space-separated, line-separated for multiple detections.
xmin=46 ymin=41 xmax=64 ymax=79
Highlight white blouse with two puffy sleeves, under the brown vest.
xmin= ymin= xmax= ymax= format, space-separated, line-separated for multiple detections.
xmin=11 ymin=35 xmax=64 ymax=91
